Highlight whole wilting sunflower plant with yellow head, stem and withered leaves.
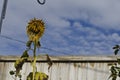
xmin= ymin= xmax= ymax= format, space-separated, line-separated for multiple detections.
xmin=10 ymin=18 xmax=52 ymax=80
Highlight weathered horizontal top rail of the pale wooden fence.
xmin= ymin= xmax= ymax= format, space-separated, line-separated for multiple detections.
xmin=0 ymin=55 xmax=120 ymax=63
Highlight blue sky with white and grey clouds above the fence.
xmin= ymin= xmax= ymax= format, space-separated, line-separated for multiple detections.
xmin=0 ymin=0 xmax=120 ymax=55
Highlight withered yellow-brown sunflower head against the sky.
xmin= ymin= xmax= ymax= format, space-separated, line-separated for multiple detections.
xmin=26 ymin=18 xmax=45 ymax=42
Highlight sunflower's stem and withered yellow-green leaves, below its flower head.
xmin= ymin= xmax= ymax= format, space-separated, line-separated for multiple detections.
xmin=9 ymin=41 xmax=53 ymax=80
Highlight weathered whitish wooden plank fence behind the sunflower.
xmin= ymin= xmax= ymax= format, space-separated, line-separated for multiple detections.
xmin=0 ymin=56 xmax=120 ymax=80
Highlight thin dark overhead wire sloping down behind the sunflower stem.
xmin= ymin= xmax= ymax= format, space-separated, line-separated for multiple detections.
xmin=0 ymin=34 xmax=70 ymax=55
